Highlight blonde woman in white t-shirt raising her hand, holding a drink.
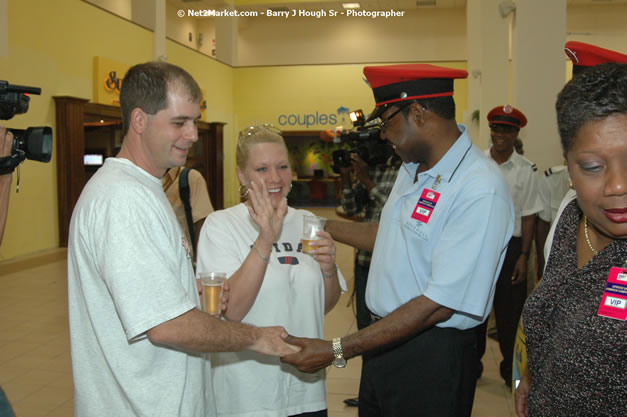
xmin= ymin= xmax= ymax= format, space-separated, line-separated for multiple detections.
xmin=198 ymin=125 xmax=346 ymax=417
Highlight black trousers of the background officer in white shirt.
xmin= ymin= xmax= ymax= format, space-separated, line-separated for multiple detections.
xmin=494 ymin=237 xmax=527 ymax=382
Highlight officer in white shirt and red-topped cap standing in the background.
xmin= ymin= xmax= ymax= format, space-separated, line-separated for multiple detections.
xmin=479 ymin=105 xmax=542 ymax=386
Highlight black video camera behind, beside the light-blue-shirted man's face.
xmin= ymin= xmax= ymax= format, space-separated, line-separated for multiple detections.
xmin=333 ymin=124 xmax=394 ymax=172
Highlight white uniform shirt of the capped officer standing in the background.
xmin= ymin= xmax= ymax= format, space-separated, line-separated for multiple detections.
xmin=484 ymin=149 xmax=542 ymax=237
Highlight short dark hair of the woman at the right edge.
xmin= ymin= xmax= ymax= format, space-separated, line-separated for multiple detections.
xmin=555 ymin=63 xmax=627 ymax=152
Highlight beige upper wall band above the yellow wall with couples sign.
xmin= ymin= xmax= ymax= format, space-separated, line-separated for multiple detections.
xmin=238 ymin=8 xmax=466 ymax=66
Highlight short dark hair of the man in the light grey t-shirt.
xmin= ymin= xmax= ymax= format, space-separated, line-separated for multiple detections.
xmin=120 ymin=61 xmax=202 ymax=135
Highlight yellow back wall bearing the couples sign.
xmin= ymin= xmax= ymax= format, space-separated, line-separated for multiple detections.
xmin=232 ymin=62 xmax=468 ymax=204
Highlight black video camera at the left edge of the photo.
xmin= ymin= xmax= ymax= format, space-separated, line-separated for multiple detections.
xmin=0 ymin=81 xmax=52 ymax=175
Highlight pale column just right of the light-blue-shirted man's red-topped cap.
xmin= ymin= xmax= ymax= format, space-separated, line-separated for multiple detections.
xmin=466 ymin=0 xmax=511 ymax=149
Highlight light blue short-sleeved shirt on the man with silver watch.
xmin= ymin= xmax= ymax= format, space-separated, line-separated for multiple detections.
xmin=366 ymin=125 xmax=514 ymax=329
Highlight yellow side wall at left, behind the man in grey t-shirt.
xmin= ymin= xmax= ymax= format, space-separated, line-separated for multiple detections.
xmin=0 ymin=0 xmax=233 ymax=260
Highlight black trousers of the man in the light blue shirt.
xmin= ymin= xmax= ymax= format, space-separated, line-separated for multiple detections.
xmin=359 ymin=327 xmax=477 ymax=417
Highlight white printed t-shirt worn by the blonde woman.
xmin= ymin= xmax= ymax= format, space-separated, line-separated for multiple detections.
xmin=198 ymin=204 xmax=346 ymax=417
